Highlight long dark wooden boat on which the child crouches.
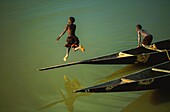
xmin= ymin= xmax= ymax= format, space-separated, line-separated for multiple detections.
xmin=38 ymin=40 xmax=170 ymax=71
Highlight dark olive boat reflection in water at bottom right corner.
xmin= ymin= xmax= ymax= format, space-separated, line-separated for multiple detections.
xmin=121 ymin=78 xmax=170 ymax=112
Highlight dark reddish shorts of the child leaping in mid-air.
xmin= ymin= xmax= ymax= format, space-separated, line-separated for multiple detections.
xmin=65 ymin=36 xmax=79 ymax=47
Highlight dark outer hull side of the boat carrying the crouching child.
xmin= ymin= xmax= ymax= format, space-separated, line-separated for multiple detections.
xmin=81 ymin=50 xmax=170 ymax=64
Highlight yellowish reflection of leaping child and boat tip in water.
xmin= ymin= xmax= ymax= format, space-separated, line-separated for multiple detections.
xmin=40 ymin=75 xmax=89 ymax=112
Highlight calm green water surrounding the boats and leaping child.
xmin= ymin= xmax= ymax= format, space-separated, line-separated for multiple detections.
xmin=0 ymin=0 xmax=170 ymax=112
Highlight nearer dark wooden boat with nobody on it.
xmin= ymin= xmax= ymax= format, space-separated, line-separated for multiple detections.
xmin=74 ymin=61 xmax=170 ymax=93
